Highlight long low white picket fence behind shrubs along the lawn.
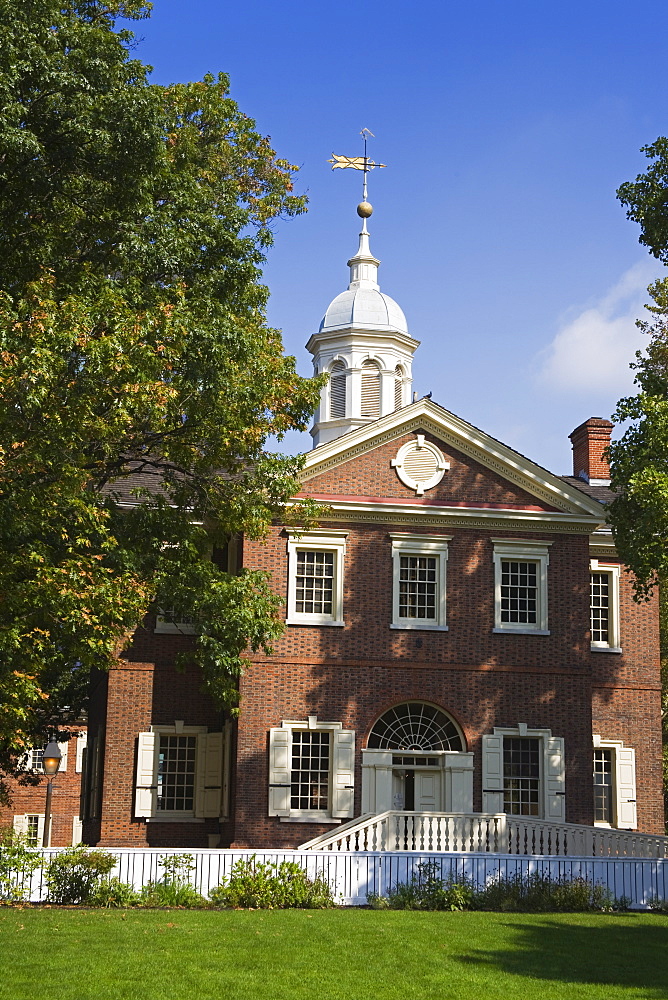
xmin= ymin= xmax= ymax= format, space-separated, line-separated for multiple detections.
xmin=7 ymin=848 xmax=668 ymax=909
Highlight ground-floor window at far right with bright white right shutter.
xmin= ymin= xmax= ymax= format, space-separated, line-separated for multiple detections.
xmin=593 ymin=735 xmax=638 ymax=830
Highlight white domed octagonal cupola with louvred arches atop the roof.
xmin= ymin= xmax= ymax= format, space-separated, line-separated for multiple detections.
xmin=306 ymin=201 xmax=420 ymax=448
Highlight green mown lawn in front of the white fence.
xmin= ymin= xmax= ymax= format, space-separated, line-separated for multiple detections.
xmin=0 ymin=908 xmax=668 ymax=1000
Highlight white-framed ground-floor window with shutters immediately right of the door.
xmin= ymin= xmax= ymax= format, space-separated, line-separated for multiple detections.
xmin=482 ymin=722 xmax=566 ymax=823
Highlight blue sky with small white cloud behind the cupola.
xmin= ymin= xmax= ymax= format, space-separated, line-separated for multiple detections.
xmin=129 ymin=0 xmax=668 ymax=474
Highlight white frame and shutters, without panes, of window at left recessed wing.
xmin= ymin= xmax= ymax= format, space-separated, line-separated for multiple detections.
xmin=134 ymin=721 xmax=229 ymax=823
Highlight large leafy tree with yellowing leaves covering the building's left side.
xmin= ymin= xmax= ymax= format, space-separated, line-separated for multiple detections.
xmin=0 ymin=0 xmax=319 ymax=796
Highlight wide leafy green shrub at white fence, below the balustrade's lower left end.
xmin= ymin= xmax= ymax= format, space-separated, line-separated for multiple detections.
xmin=209 ymin=855 xmax=334 ymax=910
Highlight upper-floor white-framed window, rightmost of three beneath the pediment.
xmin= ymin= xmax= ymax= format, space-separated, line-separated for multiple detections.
xmin=492 ymin=538 xmax=552 ymax=635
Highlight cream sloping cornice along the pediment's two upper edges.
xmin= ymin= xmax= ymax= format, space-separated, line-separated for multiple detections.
xmin=301 ymin=399 xmax=604 ymax=524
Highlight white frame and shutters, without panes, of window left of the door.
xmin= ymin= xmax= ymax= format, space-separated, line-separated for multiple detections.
xmin=269 ymin=715 xmax=355 ymax=824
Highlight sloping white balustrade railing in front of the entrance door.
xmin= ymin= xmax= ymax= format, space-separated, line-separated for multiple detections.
xmin=300 ymin=810 xmax=668 ymax=858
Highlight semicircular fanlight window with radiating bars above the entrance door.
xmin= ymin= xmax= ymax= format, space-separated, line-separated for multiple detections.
xmin=367 ymin=701 xmax=465 ymax=753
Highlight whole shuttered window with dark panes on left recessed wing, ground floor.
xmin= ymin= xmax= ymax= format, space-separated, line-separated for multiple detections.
xmin=135 ymin=721 xmax=229 ymax=823
